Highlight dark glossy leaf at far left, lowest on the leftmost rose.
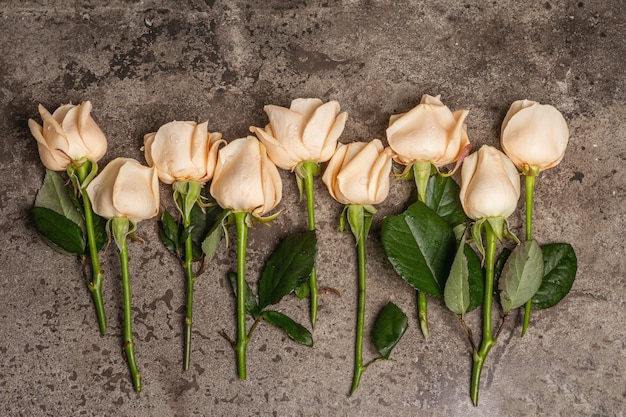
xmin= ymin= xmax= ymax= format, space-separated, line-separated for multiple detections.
xmin=32 ymin=207 xmax=85 ymax=255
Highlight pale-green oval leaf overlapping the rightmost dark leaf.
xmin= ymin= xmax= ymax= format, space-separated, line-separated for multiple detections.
xmin=498 ymin=240 xmax=543 ymax=314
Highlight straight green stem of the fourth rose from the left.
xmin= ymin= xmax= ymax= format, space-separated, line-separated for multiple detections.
xmin=233 ymin=211 xmax=248 ymax=379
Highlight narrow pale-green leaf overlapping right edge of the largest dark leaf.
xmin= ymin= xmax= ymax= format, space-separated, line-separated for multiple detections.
xmin=443 ymin=238 xmax=470 ymax=316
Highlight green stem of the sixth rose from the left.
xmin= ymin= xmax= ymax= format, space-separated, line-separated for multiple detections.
xmin=349 ymin=206 xmax=372 ymax=395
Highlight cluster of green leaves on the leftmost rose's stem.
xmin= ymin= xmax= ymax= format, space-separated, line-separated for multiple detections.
xmin=31 ymin=170 xmax=108 ymax=258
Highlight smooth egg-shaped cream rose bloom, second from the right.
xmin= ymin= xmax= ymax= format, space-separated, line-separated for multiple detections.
xmin=459 ymin=145 xmax=520 ymax=220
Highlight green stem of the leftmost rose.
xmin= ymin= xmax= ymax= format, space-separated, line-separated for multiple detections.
xmin=76 ymin=161 xmax=107 ymax=336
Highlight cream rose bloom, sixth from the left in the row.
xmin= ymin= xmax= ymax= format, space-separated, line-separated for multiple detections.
xmin=322 ymin=139 xmax=393 ymax=205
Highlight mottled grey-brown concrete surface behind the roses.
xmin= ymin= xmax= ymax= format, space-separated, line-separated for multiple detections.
xmin=0 ymin=0 xmax=626 ymax=416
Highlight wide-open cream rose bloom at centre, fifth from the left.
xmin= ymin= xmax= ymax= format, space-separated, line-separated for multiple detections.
xmin=250 ymin=98 xmax=348 ymax=170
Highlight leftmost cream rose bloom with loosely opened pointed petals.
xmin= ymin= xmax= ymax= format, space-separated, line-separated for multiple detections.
xmin=28 ymin=101 xmax=107 ymax=171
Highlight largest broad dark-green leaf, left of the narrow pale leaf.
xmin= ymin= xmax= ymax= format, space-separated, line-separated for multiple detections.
xmin=381 ymin=201 xmax=456 ymax=297
